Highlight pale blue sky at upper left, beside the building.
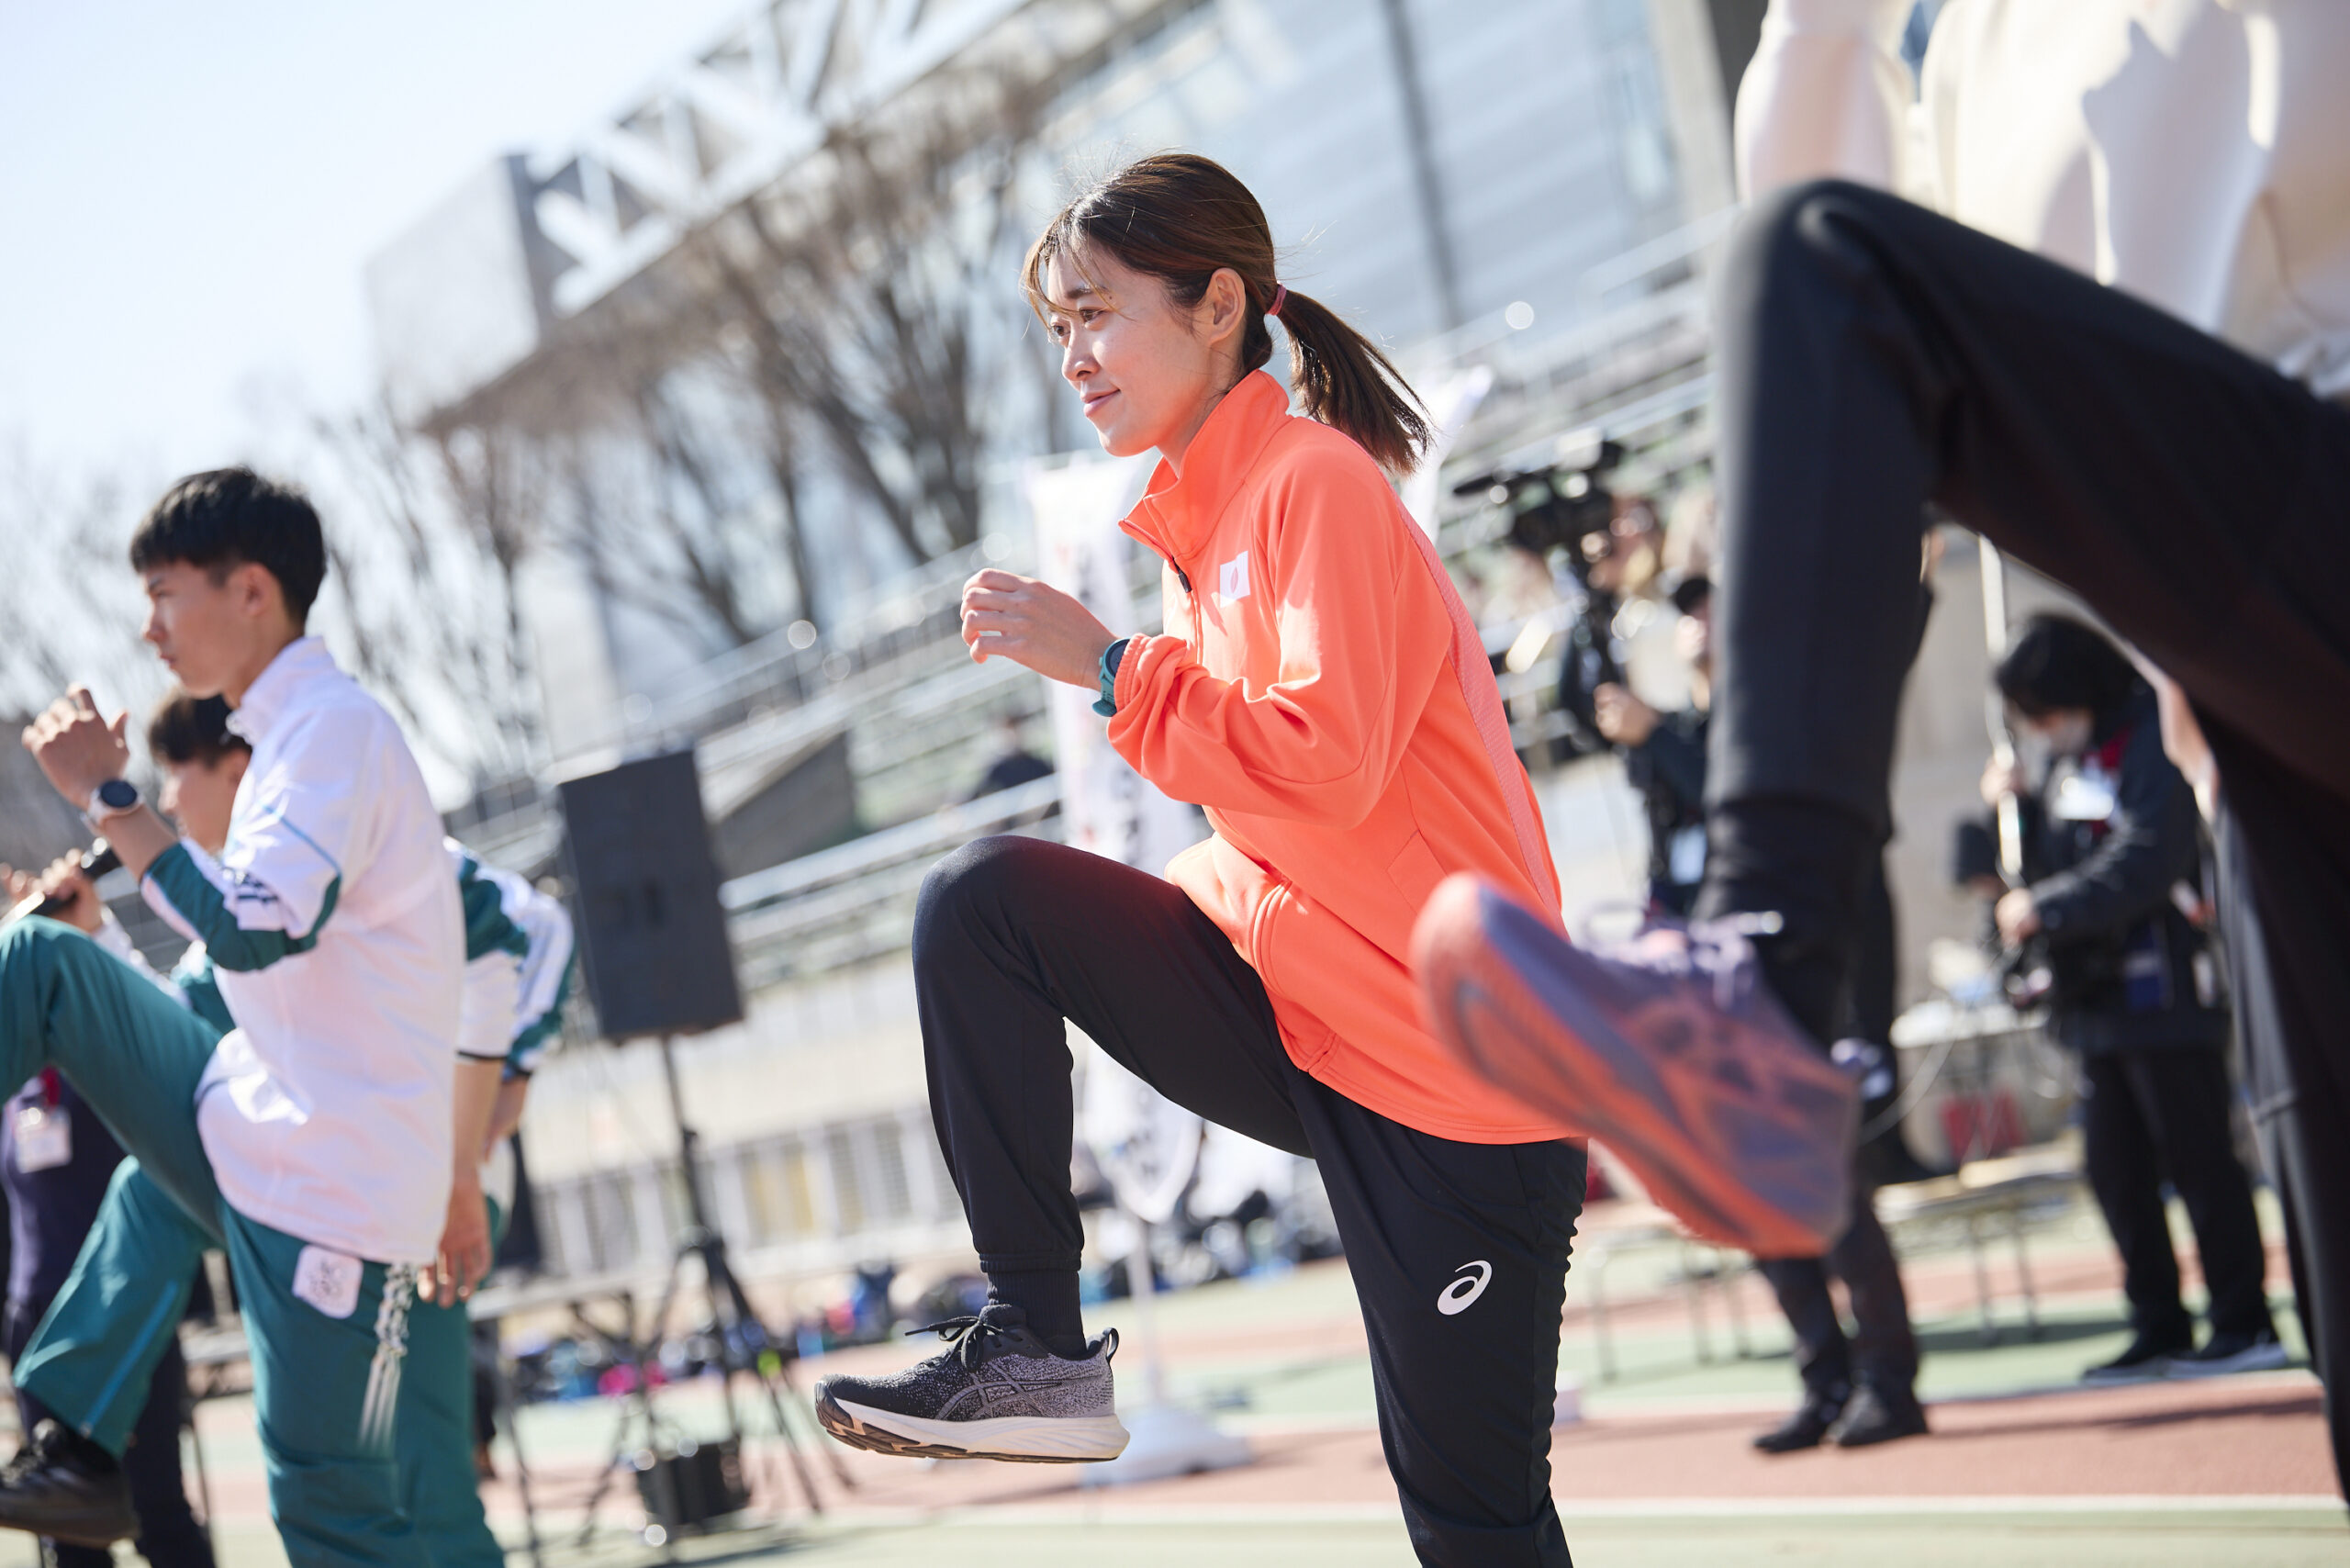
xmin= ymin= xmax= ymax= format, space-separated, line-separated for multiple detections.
xmin=0 ymin=0 xmax=745 ymax=477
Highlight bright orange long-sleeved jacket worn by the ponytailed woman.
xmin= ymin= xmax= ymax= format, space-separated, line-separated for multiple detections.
xmin=1109 ymin=372 xmax=1568 ymax=1143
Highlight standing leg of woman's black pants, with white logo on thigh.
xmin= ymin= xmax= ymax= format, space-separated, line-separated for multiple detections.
xmin=1295 ymin=1074 xmax=1589 ymax=1568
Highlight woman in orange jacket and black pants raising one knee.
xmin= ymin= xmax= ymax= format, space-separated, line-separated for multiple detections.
xmin=818 ymin=155 xmax=1586 ymax=1568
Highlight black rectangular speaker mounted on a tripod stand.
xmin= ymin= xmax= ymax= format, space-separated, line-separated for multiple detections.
xmin=559 ymin=750 xmax=743 ymax=1039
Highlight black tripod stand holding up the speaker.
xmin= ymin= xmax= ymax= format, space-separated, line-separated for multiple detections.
xmin=580 ymin=1035 xmax=856 ymax=1550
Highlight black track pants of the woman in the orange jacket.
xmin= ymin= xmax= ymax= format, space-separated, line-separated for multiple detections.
xmin=914 ymin=837 xmax=1586 ymax=1568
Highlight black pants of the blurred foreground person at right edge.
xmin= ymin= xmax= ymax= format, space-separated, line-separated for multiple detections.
xmin=1699 ymin=184 xmax=2350 ymax=1495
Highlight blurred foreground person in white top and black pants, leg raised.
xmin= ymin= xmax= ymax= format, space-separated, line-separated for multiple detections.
xmin=1428 ymin=0 xmax=2350 ymax=1495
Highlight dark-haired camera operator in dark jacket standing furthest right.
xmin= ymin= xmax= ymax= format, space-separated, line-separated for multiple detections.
xmin=1984 ymin=616 xmax=2284 ymax=1383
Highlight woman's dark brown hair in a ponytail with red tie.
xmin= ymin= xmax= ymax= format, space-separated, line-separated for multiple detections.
xmin=1020 ymin=152 xmax=1428 ymax=473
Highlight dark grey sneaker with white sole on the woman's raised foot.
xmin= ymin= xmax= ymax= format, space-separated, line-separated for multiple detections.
xmin=815 ymin=1303 xmax=1125 ymax=1464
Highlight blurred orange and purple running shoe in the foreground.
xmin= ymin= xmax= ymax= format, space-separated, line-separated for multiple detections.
xmin=1413 ymin=872 xmax=1862 ymax=1258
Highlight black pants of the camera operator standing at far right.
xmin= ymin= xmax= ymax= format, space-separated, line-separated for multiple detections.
xmin=2082 ymin=1048 xmax=2275 ymax=1340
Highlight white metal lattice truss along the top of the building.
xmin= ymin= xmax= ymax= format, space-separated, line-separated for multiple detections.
xmin=526 ymin=0 xmax=1166 ymax=315
